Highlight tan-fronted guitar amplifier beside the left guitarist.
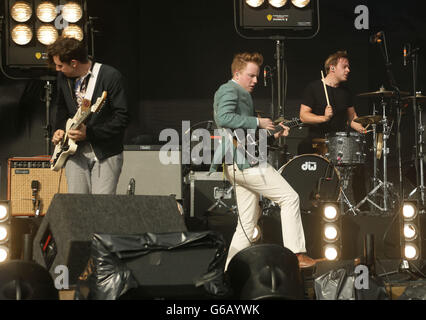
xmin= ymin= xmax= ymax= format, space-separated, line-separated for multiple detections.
xmin=7 ymin=156 xmax=67 ymax=216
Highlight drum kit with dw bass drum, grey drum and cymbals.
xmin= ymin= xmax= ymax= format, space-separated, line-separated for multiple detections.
xmin=279 ymin=88 xmax=426 ymax=215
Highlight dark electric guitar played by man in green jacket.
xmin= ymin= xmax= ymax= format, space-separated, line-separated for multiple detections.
xmin=234 ymin=118 xmax=303 ymax=165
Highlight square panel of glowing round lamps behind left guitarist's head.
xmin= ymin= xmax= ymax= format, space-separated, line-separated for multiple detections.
xmin=1 ymin=0 xmax=89 ymax=69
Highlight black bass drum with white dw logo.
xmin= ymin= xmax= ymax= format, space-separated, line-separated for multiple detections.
xmin=279 ymin=154 xmax=340 ymax=213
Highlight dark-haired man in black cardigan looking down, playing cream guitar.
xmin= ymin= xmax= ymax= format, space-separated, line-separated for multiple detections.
xmin=48 ymin=37 xmax=129 ymax=194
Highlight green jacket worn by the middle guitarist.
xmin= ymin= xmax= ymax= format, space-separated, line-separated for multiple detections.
xmin=210 ymin=80 xmax=257 ymax=172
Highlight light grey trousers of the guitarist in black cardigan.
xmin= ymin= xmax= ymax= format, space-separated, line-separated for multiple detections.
xmin=65 ymin=143 xmax=123 ymax=194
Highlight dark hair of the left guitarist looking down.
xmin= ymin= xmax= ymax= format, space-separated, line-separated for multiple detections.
xmin=47 ymin=36 xmax=89 ymax=66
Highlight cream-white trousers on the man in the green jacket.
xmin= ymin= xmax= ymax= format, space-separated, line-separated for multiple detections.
xmin=225 ymin=164 xmax=306 ymax=270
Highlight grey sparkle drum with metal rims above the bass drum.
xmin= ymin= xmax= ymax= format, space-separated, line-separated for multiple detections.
xmin=325 ymin=132 xmax=366 ymax=165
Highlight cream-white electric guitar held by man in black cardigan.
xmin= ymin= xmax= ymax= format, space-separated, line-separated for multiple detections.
xmin=50 ymin=91 xmax=107 ymax=171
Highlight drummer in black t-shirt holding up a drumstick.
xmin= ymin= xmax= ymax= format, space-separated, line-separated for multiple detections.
xmin=299 ymin=51 xmax=367 ymax=154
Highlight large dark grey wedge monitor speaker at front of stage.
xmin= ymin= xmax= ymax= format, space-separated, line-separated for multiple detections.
xmin=33 ymin=194 xmax=187 ymax=285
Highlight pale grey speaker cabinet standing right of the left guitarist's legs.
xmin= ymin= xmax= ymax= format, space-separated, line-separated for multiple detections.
xmin=117 ymin=145 xmax=182 ymax=200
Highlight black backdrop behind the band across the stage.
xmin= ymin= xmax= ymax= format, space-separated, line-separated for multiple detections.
xmin=0 ymin=0 xmax=426 ymax=199
